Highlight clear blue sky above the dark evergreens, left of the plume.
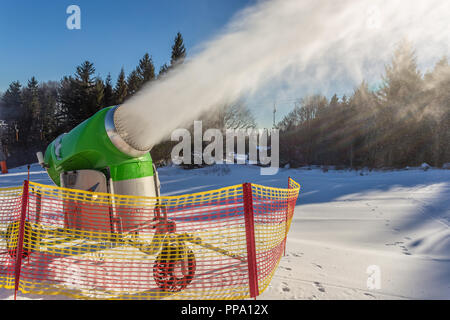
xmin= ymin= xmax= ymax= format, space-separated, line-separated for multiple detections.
xmin=0 ymin=0 xmax=256 ymax=92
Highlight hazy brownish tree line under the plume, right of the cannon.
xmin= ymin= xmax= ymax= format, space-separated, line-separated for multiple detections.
xmin=277 ymin=41 xmax=450 ymax=168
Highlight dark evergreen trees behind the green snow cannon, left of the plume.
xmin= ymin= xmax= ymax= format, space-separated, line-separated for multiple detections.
xmin=0 ymin=32 xmax=186 ymax=166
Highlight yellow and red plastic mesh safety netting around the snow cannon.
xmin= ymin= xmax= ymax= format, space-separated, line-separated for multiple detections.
xmin=0 ymin=179 xmax=300 ymax=299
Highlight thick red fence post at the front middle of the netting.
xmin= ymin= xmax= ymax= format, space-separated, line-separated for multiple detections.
xmin=242 ymin=183 xmax=259 ymax=299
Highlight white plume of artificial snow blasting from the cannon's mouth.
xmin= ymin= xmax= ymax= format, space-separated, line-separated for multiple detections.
xmin=115 ymin=0 xmax=450 ymax=150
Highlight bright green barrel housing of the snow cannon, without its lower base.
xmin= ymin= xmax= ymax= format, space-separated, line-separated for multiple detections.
xmin=38 ymin=106 xmax=155 ymax=191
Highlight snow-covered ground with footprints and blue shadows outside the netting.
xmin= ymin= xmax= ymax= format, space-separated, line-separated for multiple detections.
xmin=0 ymin=164 xmax=450 ymax=299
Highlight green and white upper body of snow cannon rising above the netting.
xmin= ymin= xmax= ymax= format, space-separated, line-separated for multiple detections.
xmin=37 ymin=106 xmax=160 ymax=229
